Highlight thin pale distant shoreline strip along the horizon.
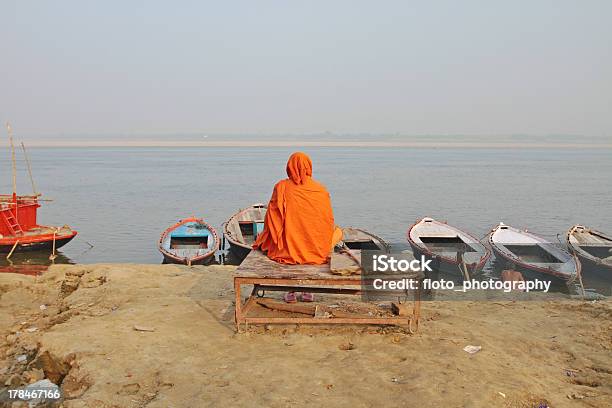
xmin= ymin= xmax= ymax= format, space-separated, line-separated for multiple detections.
xmin=10 ymin=140 xmax=612 ymax=149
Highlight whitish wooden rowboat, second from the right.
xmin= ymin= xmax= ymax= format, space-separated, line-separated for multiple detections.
xmin=489 ymin=223 xmax=581 ymax=286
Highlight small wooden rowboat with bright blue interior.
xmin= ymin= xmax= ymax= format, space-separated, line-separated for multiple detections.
xmin=159 ymin=218 xmax=220 ymax=265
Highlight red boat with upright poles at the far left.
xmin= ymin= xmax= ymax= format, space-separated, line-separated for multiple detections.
xmin=0 ymin=123 xmax=77 ymax=255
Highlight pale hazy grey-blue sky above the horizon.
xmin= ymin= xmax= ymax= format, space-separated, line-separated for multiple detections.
xmin=0 ymin=0 xmax=612 ymax=136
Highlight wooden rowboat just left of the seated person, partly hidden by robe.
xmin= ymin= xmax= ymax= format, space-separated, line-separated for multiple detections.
xmin=223 ymin=204 xmax=268 ymax=259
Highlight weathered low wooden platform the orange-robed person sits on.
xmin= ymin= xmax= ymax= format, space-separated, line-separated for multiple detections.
xmin=234 ymin=250 xmax=420 ymax=332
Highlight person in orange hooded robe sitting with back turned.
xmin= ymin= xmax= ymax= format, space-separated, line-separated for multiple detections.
xmin=253 ymin=152 xmax=341 ymax=264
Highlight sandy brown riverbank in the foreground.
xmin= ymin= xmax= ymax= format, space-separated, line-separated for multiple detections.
xmin=0 ymin=265 xmax=612 ymax=408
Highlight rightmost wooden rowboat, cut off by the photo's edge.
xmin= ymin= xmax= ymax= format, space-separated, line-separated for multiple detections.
xmin=565 ymin=225 xmax=612 ymax=279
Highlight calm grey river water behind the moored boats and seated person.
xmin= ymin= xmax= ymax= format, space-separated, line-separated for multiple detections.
xmin=0 ymin=147 xmax=612 ymax=294
